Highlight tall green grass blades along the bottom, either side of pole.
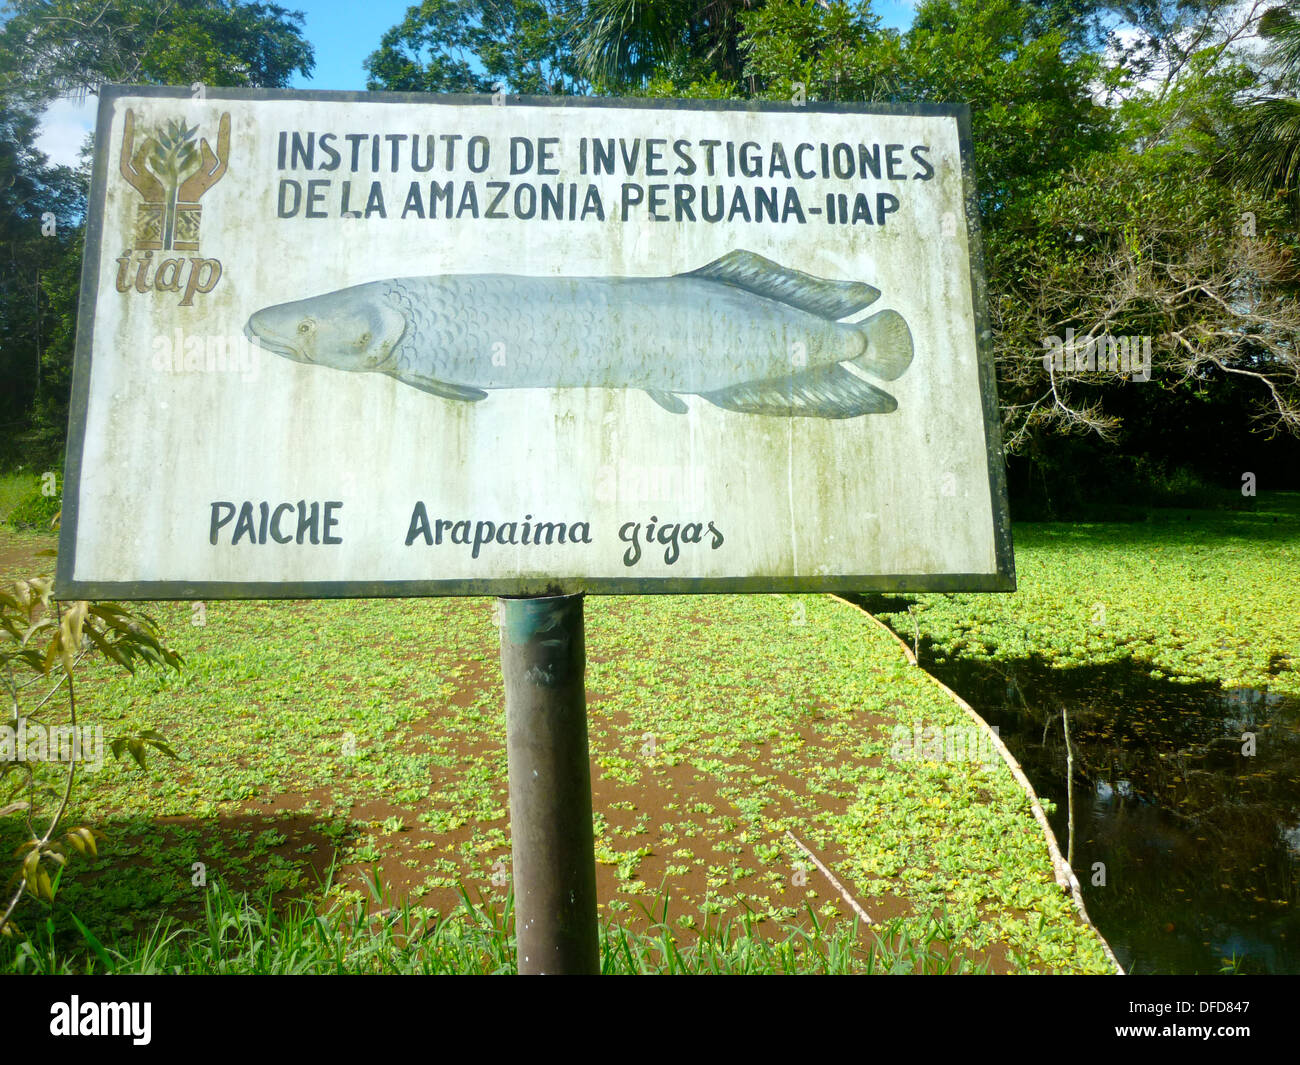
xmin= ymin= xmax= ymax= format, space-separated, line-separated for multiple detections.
xmin=0 ymin=883 xmax=984 ymax=975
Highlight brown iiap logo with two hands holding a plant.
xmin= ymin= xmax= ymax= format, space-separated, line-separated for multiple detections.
xmin=117 ymin=108 xmax=230 ymax=307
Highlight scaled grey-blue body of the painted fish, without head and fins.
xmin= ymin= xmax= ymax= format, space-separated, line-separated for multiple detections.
xmin=390 ymin=274 xmax=862 ymax=391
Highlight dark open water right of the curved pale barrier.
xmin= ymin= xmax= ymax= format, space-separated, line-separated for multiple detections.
xmin=842 ymin=600 xmax=1300 ymax=973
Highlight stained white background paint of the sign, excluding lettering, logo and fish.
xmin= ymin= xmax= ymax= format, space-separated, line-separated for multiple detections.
xmin=57 ymin=87 xmax=1014 ymax=598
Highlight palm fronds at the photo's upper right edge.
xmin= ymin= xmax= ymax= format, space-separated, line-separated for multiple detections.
xmin=1232 ymin=5 xmax=1300 ymax=212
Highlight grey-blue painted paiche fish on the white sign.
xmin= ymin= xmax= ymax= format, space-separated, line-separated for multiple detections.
xmin=244 ymin=250 xmax=913 ymax=419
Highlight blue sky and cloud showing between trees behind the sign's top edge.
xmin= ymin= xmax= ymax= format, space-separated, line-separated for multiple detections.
xmin=39 ymin=0 xmax=913 ymax=165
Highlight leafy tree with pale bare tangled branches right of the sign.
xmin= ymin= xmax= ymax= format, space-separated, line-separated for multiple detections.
xmin=991 ymin=145 xmax=1300 ymax=450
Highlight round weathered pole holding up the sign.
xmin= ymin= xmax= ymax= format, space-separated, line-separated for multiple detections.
xmin=498 ymin=596 xmax=601 ymax=974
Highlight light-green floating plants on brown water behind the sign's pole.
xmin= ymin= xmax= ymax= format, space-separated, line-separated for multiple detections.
xmin=0 ymin=525 xmax=1108 ymax=971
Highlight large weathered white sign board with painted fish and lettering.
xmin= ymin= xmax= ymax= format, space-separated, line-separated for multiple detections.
xmin=57 ymin=87 xmax=1014 ymax=598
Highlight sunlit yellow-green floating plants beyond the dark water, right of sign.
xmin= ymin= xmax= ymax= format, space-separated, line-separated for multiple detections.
xmin=868 ymin=493 xmax=1300 ymax=694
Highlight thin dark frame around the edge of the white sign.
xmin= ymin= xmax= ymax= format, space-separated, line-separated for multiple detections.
xmin=55 ymin=86 xmax=1015 ymax=599
